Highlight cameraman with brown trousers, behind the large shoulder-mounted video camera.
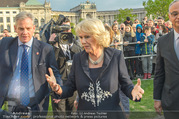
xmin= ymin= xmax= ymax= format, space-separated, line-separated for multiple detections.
xmin=49 ymin=17 xmax=82 ymax=117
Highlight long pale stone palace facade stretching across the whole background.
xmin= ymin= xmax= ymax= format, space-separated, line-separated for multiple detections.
xmin=0 ymin=0 xmax=146 ymax=34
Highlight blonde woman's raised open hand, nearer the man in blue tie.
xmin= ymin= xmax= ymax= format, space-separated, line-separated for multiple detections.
xmin=45 ymin=68 xmax=62 ymax=95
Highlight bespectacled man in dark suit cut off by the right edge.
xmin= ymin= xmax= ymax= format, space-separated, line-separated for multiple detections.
xmin=154 ymin=0 xmax=179 ymax=119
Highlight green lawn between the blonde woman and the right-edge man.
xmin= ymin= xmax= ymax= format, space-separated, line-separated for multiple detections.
xmin=130 ymin=80 xmax=157 ymax=119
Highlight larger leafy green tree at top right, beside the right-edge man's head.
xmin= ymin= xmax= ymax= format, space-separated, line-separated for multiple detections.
xmin=143 ymin=0 xmax=173 ymax=21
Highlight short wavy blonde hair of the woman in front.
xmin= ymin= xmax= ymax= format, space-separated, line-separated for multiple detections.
xmin=75 ymin=18 xmax=110 ymax=47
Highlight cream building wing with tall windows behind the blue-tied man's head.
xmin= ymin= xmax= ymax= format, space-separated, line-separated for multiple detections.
xmin=0 ymin=0 xmax=52 ymax=36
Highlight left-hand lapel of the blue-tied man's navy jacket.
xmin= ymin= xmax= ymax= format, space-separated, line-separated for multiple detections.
xmin=9 ymin=37 xmax=18 ymax=72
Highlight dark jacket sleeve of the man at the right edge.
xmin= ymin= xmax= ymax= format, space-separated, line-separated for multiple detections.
xmin=153 ymin=39 xmax=165 ymax=100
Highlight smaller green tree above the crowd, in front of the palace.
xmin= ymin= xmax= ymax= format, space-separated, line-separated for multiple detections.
xmin=116 ymin=8 xmax=137 ymax=23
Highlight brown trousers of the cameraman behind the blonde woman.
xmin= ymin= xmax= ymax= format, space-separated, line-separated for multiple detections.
xmin=51 ymin=80 xmax=77 ymax=119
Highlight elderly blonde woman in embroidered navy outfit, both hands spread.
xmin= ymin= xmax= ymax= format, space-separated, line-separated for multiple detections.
xmin=46 ymin=19 xmax=144 ymax=118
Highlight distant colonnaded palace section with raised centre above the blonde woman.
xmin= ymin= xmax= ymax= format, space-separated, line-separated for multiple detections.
xmin=52 ymin=0 xmax=147 ymax=25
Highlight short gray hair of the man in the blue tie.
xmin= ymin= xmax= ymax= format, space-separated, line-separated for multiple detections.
xmin=15 ymin=11 xmax=34 ymax=24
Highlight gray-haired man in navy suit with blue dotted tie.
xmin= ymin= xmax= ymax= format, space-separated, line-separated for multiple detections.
xmin=0 ymin=12 xmax=61 ymax=115
